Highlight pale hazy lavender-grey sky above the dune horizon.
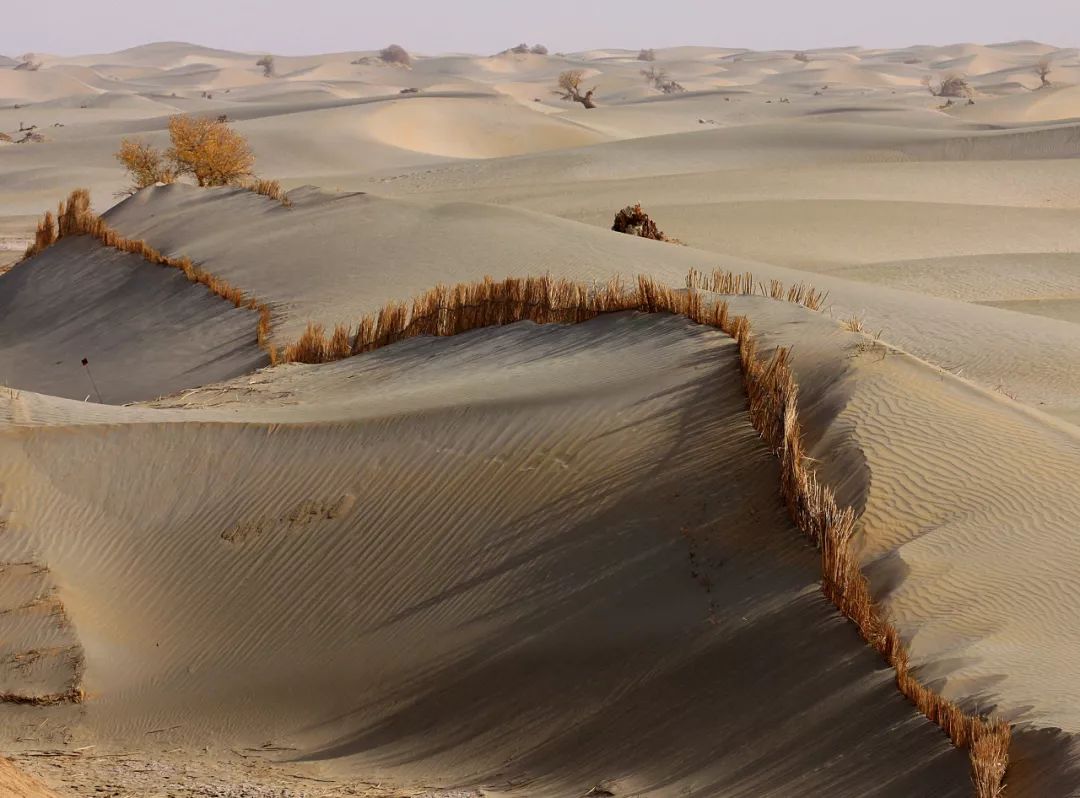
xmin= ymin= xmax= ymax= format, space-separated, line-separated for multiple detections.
xmin=0 ymin=0 xmax=1080 ymax=56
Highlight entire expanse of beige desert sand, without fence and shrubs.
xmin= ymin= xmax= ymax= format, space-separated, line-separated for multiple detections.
xmin=0 ymin=42 xmax=1080 ymax=798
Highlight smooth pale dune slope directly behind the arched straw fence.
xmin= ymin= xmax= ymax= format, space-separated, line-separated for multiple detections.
xmin=99 ymin=186 xmax=1080 ymax=419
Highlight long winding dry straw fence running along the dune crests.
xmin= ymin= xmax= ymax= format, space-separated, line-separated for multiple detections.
xmin=19 ymin=191 xmax=1011 ymax=798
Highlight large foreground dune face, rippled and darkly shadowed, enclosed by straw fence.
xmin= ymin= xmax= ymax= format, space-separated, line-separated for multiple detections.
xmin=0 ymin=315 xmax=967 ymax=796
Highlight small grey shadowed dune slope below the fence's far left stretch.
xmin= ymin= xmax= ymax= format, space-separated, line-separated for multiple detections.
xmin=0 ymin=239 xmax=265 ymax=404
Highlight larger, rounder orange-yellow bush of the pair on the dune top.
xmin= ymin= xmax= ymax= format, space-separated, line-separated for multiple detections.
xmin=165 ymin=116 xmax=255 ymax=186
